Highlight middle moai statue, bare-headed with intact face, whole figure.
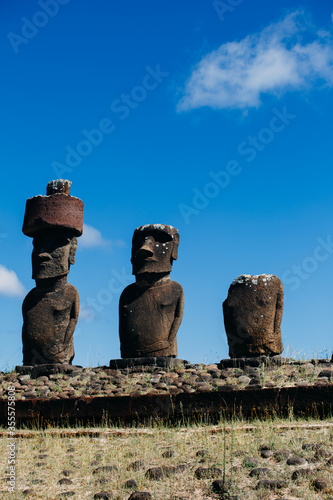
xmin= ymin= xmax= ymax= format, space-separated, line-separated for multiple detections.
xmin=119 ymin=224 xmax=184 ymax=358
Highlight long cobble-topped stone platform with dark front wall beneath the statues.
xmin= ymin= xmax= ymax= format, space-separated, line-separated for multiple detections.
xmin=0 ymin=358 xmax=333 ymax=425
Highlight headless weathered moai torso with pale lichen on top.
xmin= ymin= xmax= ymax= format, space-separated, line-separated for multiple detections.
xmin=223 ymin=274 xmax=284 ymax=358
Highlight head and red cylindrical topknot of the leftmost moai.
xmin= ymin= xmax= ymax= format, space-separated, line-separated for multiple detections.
xmin=22 ymin=179 xmax=84 ymax=280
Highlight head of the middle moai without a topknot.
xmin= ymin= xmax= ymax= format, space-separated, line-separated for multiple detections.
xmin=131 ymin=224 xmax=179 ymax=276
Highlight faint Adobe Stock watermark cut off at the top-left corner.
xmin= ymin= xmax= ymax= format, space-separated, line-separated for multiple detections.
xmin=7 ymin=0 xmax=70 ymax=54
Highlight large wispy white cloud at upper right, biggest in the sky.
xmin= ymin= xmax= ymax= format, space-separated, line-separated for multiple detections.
xmin=178 ymin=11 xmax=333 ymax=111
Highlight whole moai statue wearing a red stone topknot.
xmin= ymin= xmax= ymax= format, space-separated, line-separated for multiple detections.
xmin=22 ymin=179 xmax=84 ymax=365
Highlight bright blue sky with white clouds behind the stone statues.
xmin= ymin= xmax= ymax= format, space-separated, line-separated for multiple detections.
xmin=0 ymin=0 xmax=333 ymax=370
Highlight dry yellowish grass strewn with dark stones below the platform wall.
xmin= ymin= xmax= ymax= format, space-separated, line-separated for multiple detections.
xmin=0 ymin=419 xmax=333 ymax=500
